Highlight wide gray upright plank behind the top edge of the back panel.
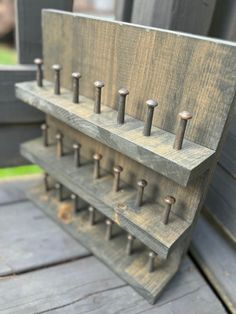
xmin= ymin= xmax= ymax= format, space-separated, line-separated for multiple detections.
xmin=131 ymin=0 xmax=216 ymax=35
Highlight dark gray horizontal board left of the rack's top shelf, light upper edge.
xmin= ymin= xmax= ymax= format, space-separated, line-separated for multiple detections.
xmin=0 ymin=65 xmax=44 ymax=124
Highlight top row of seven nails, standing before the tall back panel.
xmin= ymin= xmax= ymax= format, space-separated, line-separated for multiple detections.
xmin=34 ymin=59 xmax=192 ymax=150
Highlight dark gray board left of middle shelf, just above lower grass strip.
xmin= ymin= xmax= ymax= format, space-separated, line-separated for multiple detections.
xmin=0 ymin=124 xmax=41 ymax=167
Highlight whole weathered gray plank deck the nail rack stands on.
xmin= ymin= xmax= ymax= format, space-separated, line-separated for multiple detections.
xmin=0 ymin=176 xmax=236 ymax=314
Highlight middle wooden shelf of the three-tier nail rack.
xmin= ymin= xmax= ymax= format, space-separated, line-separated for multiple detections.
xmin=21 ymin=139 xmax=190 ymax=259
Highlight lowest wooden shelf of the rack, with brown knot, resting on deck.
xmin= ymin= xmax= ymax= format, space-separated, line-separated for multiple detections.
xmin=28 ymin=185 xmax=179 ymax=304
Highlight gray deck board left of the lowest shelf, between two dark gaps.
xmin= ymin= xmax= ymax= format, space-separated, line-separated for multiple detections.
xmin=0 ymin=201 xmax=89 ymax=276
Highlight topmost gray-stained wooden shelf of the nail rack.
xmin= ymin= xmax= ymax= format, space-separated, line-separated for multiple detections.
xmin=16 ymin=81 xmax=215 ymax=186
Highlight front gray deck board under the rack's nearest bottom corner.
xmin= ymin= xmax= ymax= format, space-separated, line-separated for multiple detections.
xmin=0 ymin=257 xmax=226 ymax=314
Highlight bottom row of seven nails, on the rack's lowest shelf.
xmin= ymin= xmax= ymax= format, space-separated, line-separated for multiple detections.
xmin=44 ymin=173 xmax=157 ymax=273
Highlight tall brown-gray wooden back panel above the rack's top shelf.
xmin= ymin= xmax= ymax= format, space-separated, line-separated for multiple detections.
xmin=43 ymin=10 xmax=236 ymax=149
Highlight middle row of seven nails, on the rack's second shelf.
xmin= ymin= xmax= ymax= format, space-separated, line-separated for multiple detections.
xmin=41 ymin=124 xmax=176 ymax=225
